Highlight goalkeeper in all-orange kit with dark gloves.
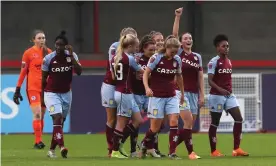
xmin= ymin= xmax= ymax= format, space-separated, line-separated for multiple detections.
xmin=13 ymin=30 xmax=52 ymax=149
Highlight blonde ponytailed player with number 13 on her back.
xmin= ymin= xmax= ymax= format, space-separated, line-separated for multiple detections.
xmin=111 ymin=34 xmax=144 ymax=158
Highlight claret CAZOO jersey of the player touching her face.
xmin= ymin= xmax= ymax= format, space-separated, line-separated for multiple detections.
xmin=42 ymin=51 xmax=79 ymax=93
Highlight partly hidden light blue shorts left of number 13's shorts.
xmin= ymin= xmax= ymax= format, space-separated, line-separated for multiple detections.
xmin=101 ymin=82 xmax=117 ymax=108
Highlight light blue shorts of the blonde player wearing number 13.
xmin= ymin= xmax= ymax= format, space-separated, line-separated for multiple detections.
xmin=114 ymin=91 xmax=140 ymax=118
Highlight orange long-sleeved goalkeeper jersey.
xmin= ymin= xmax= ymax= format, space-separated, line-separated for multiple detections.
xmin=17 ymin=46 xmax=52 ymax=92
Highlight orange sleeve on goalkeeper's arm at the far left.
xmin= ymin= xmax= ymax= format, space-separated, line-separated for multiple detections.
xmin=16 ymin=51 xmax=30 ymax=87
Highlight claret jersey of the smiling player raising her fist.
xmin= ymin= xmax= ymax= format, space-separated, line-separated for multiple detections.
xmin=177 ymin=48 xmax=203 ymax=93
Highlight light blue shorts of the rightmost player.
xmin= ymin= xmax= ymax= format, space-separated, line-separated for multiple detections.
xmin=208 ymin=94 xmax=239 ymax=112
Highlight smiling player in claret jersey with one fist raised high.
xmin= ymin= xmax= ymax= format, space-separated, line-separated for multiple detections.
xmin=168 ymin=6 xmax=201 ymax=160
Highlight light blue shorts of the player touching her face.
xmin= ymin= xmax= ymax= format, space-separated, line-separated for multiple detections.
xmin=44 ymin=91 xmax=72 ymax=118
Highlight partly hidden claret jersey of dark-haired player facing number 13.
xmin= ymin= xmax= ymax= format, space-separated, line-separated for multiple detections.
xmin=132 ymin=54 xmax=149 ymax=95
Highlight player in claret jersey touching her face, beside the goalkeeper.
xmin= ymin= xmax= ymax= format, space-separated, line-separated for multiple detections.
xmin=41 ymin=31 xmax=82 ymax=158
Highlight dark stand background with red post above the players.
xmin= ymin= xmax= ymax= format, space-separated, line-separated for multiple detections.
xmin=1 ymin=2 xmax=276 ymax=67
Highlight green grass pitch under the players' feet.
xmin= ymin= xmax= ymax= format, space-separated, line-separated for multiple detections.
xmin=1 ymin=134 xmax=276 ymax=166
